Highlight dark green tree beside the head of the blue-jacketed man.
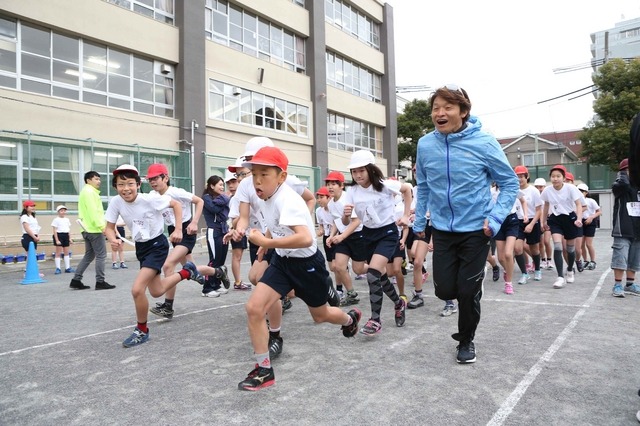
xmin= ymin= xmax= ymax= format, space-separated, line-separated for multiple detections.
xmin=398 ymin=99 xmax=434 ymax=164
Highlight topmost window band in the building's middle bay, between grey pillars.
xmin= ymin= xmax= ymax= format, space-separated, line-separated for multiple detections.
xmin=205 ymin=0 xmax=306 ymax=73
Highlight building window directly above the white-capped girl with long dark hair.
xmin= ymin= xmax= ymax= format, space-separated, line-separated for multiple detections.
xmin=327 ymin=113 xmax=383 ymax=157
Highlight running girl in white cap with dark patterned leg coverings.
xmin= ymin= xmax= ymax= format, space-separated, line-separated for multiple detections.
xmin=342 ymin=150 xmax=412 ymax=336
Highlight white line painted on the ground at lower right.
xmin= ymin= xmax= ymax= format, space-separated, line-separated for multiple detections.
xmin=487 ymin=268 xmax=611 ymax=426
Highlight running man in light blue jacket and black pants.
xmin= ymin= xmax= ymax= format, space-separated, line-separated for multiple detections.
xmin=413 ymin=85 xmax=518 ymax=364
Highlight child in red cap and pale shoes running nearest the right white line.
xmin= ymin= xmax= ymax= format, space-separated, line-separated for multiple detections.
xmin=541 ymin=164 xmax=582 ymax=288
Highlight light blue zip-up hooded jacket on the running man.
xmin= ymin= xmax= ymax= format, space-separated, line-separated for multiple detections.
xmin=413 ymin=116 xmax=519 ymax=235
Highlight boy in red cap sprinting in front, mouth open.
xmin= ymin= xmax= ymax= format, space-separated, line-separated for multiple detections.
xmin=238 ymin=147 xmax=362 ymax=390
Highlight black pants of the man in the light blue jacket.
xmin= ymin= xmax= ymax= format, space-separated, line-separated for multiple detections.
xmin=433 ymin=229 xmax=489 ymax=342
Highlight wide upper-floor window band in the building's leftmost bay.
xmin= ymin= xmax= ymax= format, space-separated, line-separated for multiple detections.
xmin=0 ymin=14 xmax=174 ymax=117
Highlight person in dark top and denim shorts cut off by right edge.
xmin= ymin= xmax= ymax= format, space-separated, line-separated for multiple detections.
xmin=611 ymin=158 xmax=640 ymax=297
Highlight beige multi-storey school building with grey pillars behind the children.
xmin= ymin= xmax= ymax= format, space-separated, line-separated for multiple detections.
xmin=0 ymin=0 xmax=398 ymax=244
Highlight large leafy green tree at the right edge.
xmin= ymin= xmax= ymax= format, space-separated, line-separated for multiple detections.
xmin=579 ymin=59 xmax=640 ymax=170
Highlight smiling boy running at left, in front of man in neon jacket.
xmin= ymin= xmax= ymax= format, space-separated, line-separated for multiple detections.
xmin=105 ymin=164 xmax=202 ymax=348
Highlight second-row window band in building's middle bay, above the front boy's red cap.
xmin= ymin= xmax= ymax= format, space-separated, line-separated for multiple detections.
xmin=209 ymin=80 xmax=309 ymax=137
